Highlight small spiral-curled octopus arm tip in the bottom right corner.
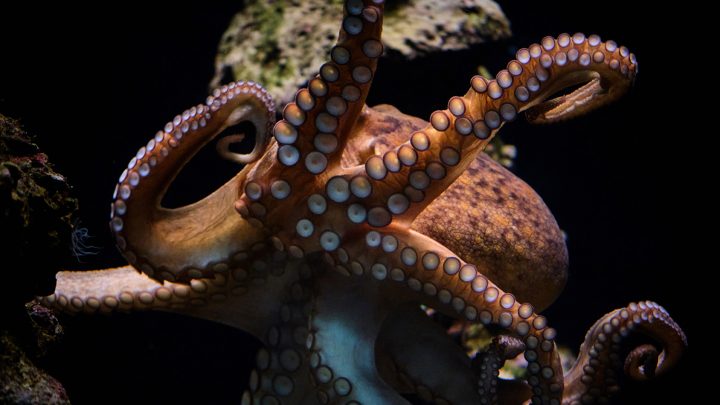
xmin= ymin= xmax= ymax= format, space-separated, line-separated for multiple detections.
xmin=562 ymin=301 xmax=687 ymax=405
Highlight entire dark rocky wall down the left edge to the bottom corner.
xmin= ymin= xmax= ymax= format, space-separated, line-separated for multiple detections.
xmin=0 ymin=115 xmax=77 ymax=404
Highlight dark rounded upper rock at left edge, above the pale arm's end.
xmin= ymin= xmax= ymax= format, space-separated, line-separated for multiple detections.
xmin=0 ymin=115 xmax=77 ymax=313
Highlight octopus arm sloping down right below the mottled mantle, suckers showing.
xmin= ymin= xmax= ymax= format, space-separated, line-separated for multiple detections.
xmin=326 ymin=227 xmax=563 ymax=404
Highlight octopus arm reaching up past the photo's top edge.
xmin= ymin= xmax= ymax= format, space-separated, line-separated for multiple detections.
xmin=274 ymin=0 xmax=384 ymax=174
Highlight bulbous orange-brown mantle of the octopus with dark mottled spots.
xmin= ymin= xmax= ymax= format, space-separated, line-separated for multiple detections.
xmin=343 ymin=105 xmax=568 ymax=310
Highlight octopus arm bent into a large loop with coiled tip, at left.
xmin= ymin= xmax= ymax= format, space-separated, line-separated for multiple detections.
xmin=110 ymin=82 xmax=275 ymax=281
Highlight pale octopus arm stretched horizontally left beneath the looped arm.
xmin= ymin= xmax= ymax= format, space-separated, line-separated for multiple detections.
xmin=41 ymin=261 xmax=298 ymax=339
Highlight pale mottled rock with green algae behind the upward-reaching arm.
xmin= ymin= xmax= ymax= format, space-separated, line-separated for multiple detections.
xmin=212 ymin=0 xmax=510 ymax=107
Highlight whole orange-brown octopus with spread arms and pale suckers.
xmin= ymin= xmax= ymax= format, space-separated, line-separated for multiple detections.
xmin=43 ymin=0 xmax=686 ymax=404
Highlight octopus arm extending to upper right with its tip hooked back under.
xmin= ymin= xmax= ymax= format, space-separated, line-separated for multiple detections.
xmin=347 ymin=33 xmax=637 ymax=226
